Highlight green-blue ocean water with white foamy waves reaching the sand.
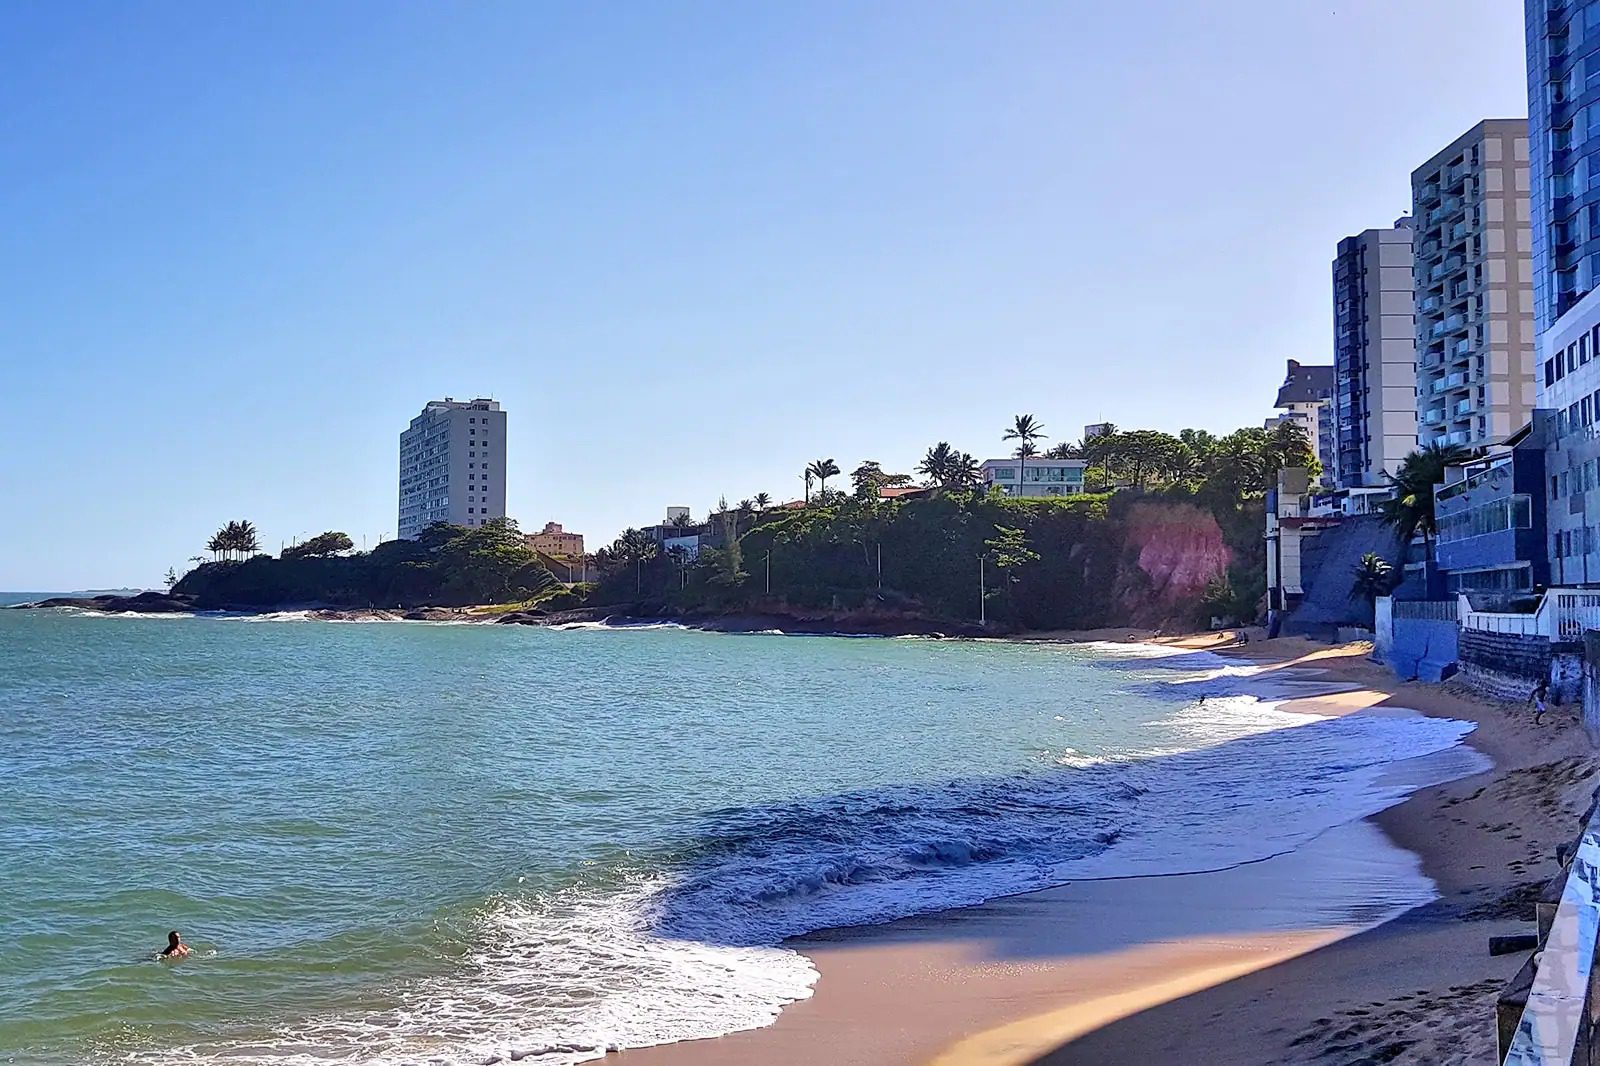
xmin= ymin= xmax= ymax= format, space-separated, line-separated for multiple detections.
xmin=0 ymin=601 xmax=1475 ymax=1066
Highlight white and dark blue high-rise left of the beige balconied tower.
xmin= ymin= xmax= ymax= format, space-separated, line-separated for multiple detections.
xmin=1326 ymin=218 xmax=1418 ymax=488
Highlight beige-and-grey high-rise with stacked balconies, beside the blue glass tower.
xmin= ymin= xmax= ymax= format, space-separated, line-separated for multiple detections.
xmin=1411 ymin=118 xmax=1534 ymax=448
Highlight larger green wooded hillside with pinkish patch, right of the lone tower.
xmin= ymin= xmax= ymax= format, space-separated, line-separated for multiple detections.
xmin=590 ymin=415 xmax=1317 ymax=629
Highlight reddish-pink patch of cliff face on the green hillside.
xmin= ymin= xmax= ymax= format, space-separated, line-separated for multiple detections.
xmin=1117 ymin=501 xmax=1232 ymax=626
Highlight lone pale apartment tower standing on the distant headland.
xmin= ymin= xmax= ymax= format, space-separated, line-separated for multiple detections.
xmin=398 ymin=395 xmax=506 ymax=539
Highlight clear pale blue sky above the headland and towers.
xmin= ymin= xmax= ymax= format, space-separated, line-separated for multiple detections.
xmin=0 ymin=0 xmax=1526 ymax=591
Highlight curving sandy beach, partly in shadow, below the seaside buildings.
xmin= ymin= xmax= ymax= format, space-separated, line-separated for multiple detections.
xmin=608 ymin=631 xmax=1597 ymax=1066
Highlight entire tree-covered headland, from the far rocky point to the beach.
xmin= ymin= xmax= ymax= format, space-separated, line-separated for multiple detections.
xmin=50 ymin=415 xmax=1317 ymax=632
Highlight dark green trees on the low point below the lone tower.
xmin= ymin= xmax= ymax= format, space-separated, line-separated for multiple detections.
xmin=173 ymin=519 xmax=563 ymax=608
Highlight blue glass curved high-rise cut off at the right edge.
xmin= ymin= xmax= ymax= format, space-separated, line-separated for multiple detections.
xmin=1523 ymin=0 xmax=1600 ymax=333
